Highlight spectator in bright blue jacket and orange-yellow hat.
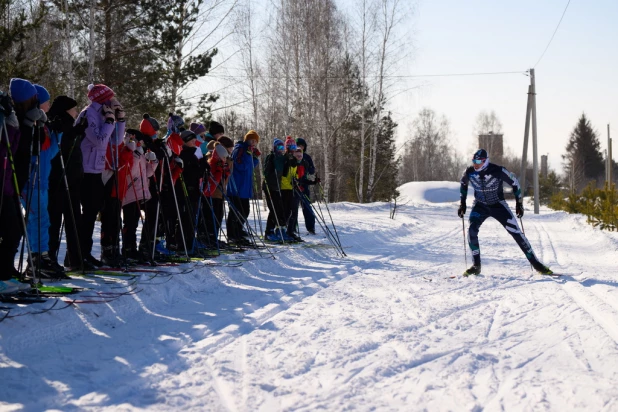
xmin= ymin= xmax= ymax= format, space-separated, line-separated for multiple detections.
xmin=227 ymin=130 xmax=261 ymax=245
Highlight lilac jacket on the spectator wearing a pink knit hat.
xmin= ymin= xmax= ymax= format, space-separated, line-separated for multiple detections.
xmin=75 ymin=102 xmax=125 ymax=173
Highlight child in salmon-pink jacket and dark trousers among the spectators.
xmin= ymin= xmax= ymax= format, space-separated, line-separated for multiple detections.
xmin=119 ymin=129 xmax=158 ymax=262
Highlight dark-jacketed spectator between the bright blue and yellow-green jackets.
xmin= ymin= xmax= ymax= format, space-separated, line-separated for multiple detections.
xmin=262 ymin=139 xmax=288 ymax=242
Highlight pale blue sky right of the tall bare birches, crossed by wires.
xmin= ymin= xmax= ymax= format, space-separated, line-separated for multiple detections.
xmin=393 ymin=0 xmax=618 ymax=170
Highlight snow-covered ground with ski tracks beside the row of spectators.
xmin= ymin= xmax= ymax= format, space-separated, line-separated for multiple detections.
xmin=0 ymin=182 xmax=618 ymax=411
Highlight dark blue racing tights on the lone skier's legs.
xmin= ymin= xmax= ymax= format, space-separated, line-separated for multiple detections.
xmin=468 ymin=200 xmax=538 ymax=266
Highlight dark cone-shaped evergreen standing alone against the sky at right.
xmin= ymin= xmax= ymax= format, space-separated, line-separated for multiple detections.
xmin=562 ymin=113 xmax=604 ymax=191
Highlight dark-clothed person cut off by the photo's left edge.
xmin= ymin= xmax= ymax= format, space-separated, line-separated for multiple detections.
xmin=0 ymin=91 xmax=30 ymax=294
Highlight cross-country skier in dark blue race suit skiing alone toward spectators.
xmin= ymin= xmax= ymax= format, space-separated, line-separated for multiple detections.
xmin=457 ymin=149 xmax=553 ymax=276
